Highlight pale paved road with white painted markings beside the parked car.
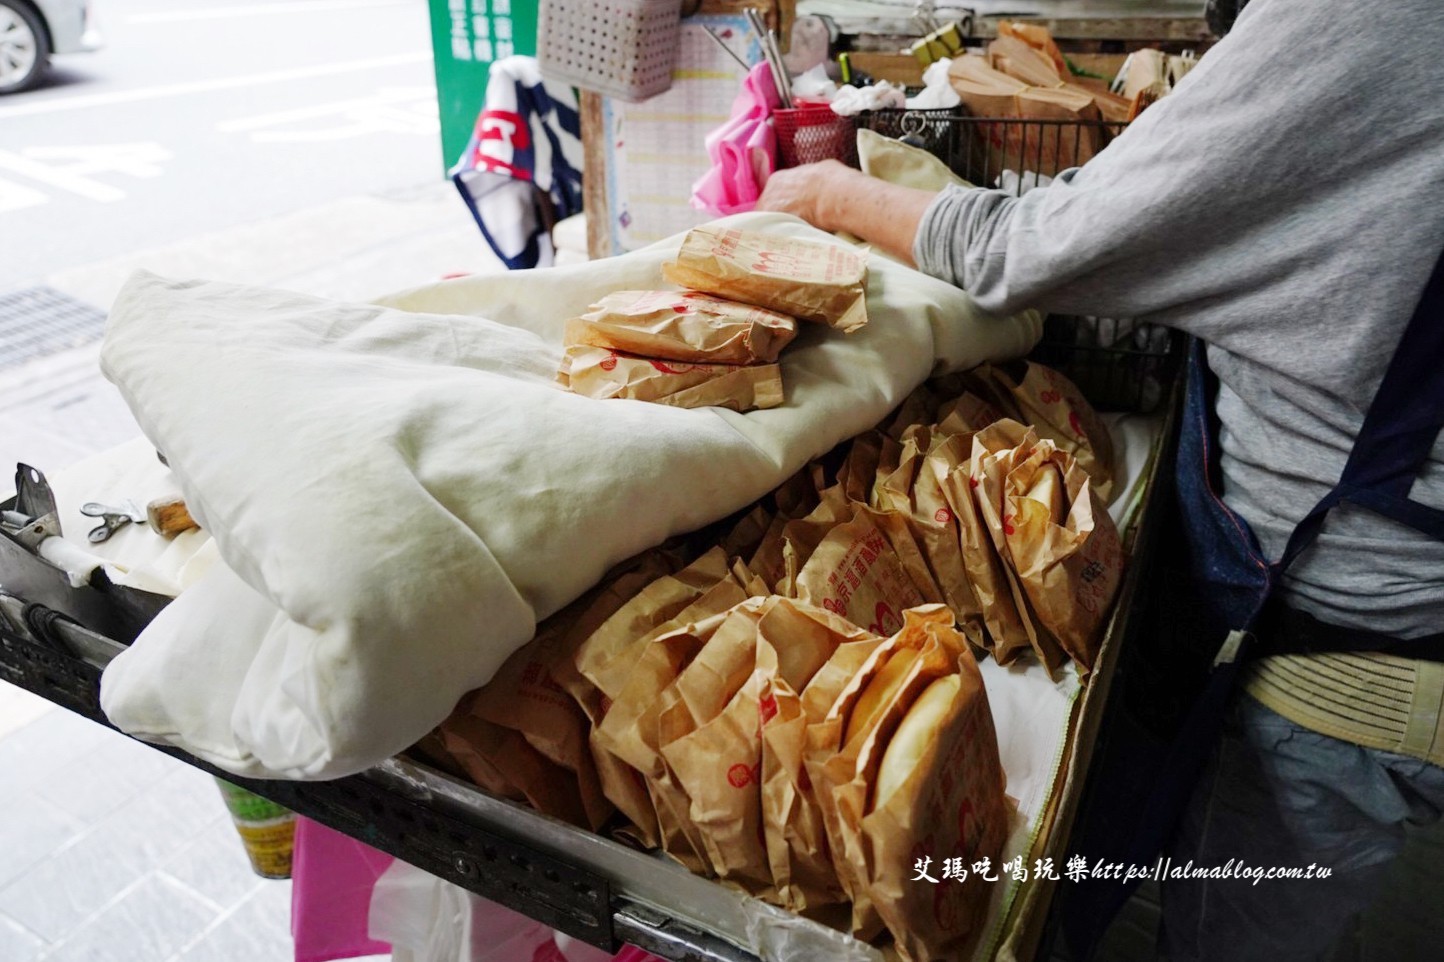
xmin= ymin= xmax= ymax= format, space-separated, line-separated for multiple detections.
xmin=0 ymin=0 xmax=445 ymax=292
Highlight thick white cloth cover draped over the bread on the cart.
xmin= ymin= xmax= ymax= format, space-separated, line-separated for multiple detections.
xmin=101 ymin=214 xmax=1041 ymax=779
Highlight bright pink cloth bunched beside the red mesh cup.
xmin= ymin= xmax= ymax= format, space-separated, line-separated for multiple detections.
xmin=692 ymin=64 xmax=781 ymax=215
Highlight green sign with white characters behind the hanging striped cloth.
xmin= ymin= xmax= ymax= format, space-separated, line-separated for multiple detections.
xmin=430 ymin=0 xmax=539 ymax=169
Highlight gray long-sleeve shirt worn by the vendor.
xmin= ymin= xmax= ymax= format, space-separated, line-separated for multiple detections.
xmin=914 ymin=0 xmax=1444 ymax=637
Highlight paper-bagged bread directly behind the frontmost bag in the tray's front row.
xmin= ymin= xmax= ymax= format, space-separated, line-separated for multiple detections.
xmin=807 ymin=605 xmax=967 ymax=940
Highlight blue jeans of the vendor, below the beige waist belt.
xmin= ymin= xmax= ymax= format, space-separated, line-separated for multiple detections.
xmin=1160 ymin=692 xmax=1444 ymax=962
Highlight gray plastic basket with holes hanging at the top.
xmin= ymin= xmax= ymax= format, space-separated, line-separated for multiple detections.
xmin=537 ymin=0 xmax=682 ymax=103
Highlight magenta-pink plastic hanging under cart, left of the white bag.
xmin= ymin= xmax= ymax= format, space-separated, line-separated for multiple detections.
xmin=290 ymin=816 xmax=394 ymax=962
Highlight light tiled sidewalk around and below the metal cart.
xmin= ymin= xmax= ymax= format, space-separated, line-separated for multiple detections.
xmin=0 ymin=174 xmax=501 ymax=962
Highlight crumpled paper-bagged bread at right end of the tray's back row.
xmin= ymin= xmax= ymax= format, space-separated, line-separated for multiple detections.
xmin=1004 ymin=441 xmax=1123 ymax=670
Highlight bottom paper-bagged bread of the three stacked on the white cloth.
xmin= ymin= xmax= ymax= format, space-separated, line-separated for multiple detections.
xmin=557 ymin=347 xmax=783 ymax=412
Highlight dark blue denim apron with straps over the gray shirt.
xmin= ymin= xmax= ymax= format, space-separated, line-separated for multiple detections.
xmin=1066 ymin=247 xmax=1444 ymax=958
